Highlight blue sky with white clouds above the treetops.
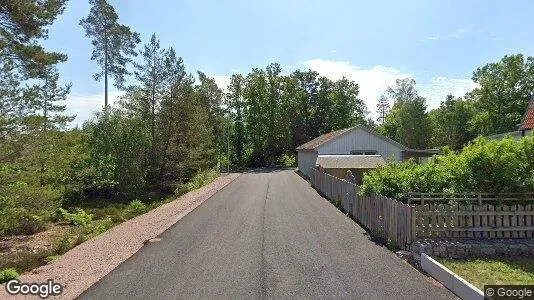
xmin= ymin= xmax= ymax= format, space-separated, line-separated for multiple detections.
xmin=44 ymin=0 xmax=534 ymax=123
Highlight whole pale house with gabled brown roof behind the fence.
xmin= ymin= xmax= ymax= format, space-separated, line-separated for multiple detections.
xmin=296 ymin=125 xmax=414 ymax=176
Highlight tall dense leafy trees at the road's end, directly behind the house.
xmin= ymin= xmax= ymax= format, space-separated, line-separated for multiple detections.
xmin=226 ymin=63 xmax=367 ymax=167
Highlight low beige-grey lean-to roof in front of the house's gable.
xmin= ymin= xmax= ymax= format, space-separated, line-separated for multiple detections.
xmin=316 ymin=155 xmax=386 ymax=169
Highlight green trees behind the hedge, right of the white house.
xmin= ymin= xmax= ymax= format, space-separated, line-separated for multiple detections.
xmin=377 ymin=54 xmax=534 ymax=150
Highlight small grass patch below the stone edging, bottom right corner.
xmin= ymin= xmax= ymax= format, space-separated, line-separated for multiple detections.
xmin=439 ymin=256 xmax=534 ymax=289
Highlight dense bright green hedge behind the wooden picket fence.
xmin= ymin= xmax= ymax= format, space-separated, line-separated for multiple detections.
xmin=362 ymin=135 xmax=534 ymax=199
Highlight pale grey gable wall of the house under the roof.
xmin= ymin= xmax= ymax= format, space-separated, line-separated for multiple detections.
xmin=317 ymin=128 xmax=402 ymax=161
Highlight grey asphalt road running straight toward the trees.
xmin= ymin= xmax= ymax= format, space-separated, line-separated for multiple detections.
xmin=80 ymin=170 xmax=455 ymax=299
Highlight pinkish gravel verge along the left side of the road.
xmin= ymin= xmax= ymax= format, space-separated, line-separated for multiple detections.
xmin=0 ymin=173 xmax=241 ymax=299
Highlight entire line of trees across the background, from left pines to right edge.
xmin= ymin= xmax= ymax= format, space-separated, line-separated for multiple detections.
xmin=0 ymin=0 xmax=534 ymax=223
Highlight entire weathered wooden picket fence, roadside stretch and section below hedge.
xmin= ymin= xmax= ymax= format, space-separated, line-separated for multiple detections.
xmin=310 ymin=168 xmax=534 ymax=249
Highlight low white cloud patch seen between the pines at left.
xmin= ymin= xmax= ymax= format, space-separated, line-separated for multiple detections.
xmin=65 ymin=91 xmax=123 ymax=125
